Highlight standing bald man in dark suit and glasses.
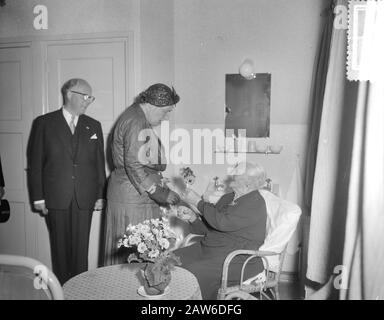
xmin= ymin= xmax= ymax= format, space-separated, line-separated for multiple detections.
xmin=29 ymin=79 xmax=106 ymax=284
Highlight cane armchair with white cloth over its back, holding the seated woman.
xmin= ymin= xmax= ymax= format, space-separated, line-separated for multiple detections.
xmin=218 ymin=190 xmax=301 ymax=300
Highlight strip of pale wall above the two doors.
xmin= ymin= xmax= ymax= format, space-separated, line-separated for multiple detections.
xmin=0 ymin=0 xmax=140 ymax=37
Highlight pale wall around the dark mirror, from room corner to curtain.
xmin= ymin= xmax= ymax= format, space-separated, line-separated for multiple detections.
xmin=175 ymin=0 xmax=327 ymax=192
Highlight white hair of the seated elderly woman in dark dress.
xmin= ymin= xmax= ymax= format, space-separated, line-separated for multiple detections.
xmin=230 ymin=161 xmax=267 ymax=190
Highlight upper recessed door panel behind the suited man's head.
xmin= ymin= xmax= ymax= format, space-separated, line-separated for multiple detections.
xmin=47 ymin=40 xmax=126 ymax=134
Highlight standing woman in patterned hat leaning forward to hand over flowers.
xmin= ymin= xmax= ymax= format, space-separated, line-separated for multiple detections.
xmin=104 ymin=83 xmax=180 ymax=265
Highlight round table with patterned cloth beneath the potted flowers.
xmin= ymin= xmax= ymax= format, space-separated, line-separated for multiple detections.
xmin=63 ymin=263 xmax=202 ymax=300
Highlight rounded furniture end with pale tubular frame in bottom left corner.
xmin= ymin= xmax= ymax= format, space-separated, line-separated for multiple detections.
xmin=0 ymin=255 xmax=64 ymax=300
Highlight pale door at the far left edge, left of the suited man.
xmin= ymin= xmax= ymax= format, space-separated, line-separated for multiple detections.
xmin=0 ymin=44 xmax=36 ymax=256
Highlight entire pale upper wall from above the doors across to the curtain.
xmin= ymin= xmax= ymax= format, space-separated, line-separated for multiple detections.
xmin=0 ymin=0 xmax=328 ymax=276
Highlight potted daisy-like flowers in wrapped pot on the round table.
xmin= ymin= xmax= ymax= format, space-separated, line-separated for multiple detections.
xmin=118 ymin=219 xmax=181 ymax=295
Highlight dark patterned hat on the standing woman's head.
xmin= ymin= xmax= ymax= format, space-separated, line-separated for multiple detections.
xmin=139 ymin=83 xmax=180 ymax=107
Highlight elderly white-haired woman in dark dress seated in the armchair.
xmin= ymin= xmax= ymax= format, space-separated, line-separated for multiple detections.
xmin=175 ymin=163 xmax=267 ymax=300
